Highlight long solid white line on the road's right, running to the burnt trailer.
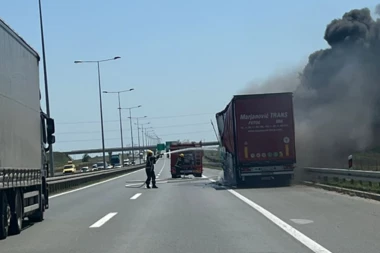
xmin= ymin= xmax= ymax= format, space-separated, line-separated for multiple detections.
xmin=203 ymin=174 xmax=332 ymax=253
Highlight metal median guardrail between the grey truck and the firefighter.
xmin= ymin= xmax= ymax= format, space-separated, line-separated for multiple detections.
xmin=46 ymin=165 xmax=145 ymax=194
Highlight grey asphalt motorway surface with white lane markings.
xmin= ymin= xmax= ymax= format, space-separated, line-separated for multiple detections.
xmin=0 ymin=159 xmax=380 ymax=253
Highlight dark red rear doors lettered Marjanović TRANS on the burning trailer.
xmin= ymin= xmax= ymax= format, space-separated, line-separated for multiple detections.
xmin=235 ymin=93 xmax=296 ymax=165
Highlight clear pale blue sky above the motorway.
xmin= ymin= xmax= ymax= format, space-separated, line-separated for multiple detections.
xmin=0 ymin=0 xmax=378 ymax=157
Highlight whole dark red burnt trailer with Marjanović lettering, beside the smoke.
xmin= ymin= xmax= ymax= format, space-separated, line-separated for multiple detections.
xmin=216 ymin=93 xmax=296 ymax=185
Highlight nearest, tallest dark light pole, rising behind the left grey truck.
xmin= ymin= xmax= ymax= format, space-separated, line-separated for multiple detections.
xmin=38 ymin=0 xmax=54 ymax=177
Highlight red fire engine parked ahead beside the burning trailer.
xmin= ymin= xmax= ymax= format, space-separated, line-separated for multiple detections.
xmin=170 ymin=142 xmax=203 ymax=178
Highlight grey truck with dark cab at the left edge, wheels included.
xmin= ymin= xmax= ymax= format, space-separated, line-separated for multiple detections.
xmin=0 ymin=20 xmax=55 ymax=239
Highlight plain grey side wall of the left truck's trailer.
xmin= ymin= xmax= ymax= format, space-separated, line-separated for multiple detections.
xmin=0 ymin=20 xmax=41 ymax=169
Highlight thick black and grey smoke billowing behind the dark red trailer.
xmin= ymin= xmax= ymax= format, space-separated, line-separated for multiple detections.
xmin=244 ymin=5 xmax=380 ymax=167
